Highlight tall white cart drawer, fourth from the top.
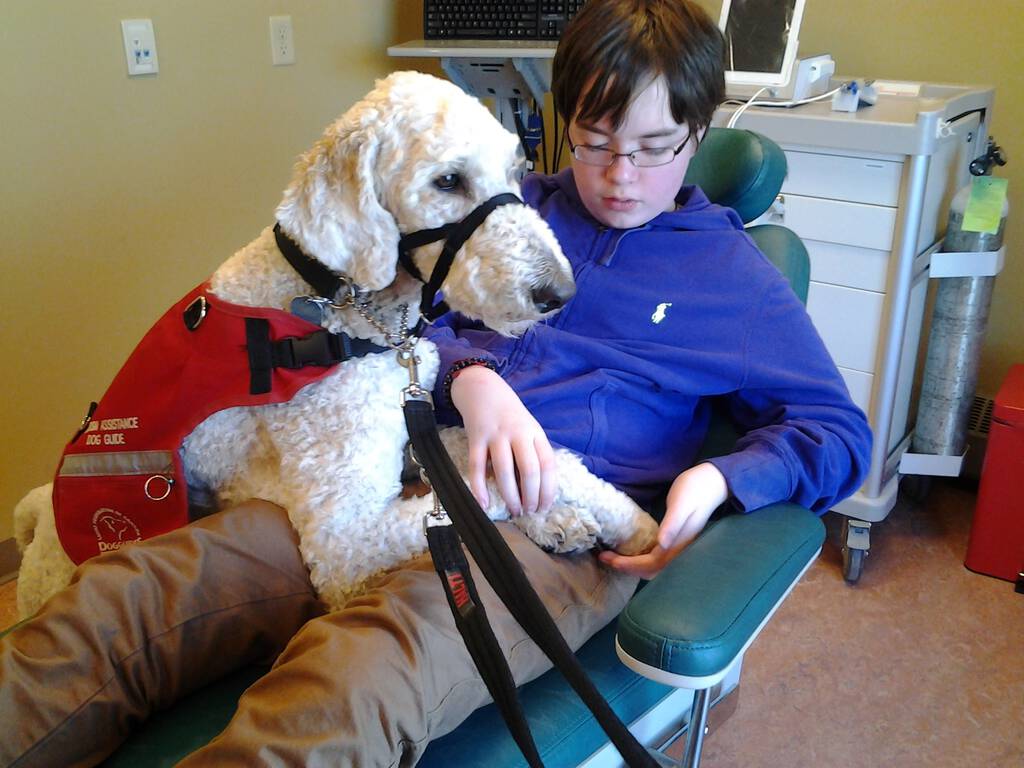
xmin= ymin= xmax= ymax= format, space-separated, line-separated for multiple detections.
xmin=807 ymin=281 xmax=885 ymax=374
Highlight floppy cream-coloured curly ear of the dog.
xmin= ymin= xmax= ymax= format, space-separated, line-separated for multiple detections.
xmin=278 ymin=118 xmax=400 ymax=291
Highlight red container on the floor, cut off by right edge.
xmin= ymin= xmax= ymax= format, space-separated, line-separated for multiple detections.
xmin=964 ymin=365 xmax=1024 ymax=582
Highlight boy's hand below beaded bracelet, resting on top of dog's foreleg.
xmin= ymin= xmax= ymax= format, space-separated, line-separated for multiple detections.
xmin=451 ymin=366 xmax=557 ymax=515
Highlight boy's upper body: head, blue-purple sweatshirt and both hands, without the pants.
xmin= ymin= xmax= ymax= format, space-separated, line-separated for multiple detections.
xmin=431 ymin=0 xmax=870 ymax=579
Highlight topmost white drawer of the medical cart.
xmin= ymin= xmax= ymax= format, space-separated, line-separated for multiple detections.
xmin=782 ymin=150 xmax=903 ymax=208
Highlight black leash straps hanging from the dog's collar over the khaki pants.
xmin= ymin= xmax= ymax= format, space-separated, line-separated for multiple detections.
xmin=403 ymin=397 xmax=658 ymax=768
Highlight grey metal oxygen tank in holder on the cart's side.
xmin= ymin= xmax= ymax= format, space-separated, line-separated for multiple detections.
xmin=912 ymin=176 xmax=1010 ymax=456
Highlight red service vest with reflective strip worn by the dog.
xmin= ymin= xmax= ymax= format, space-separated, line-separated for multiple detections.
xmin=53 ymin=284 xmax=350 ymax=563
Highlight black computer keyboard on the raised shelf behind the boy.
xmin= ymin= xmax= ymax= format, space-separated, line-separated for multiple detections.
xmin=423 ymin=0 xmax=586 ymax=40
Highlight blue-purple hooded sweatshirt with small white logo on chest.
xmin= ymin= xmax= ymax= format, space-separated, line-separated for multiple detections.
xmin=429 ymin=169 xmax=871 ymax=513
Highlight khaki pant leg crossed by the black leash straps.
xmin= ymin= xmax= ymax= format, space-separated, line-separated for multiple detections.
xmin=180 ymin=524 xmax=637 ymax=768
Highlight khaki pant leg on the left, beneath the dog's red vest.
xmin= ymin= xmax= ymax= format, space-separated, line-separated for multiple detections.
xmin=0 ymin=502 xmax=323 ymax=768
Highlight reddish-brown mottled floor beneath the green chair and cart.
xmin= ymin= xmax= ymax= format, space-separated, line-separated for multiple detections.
xmin=0 ymin=483 xmax=1024 ymax=768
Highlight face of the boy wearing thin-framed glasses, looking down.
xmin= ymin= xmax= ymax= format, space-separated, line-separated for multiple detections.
xmin=568 ymin=78 xmax=698 ymax=229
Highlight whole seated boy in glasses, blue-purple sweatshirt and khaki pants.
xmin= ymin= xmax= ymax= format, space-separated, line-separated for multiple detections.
xmin=0 ymin=0 xmax=868 ymax=767
